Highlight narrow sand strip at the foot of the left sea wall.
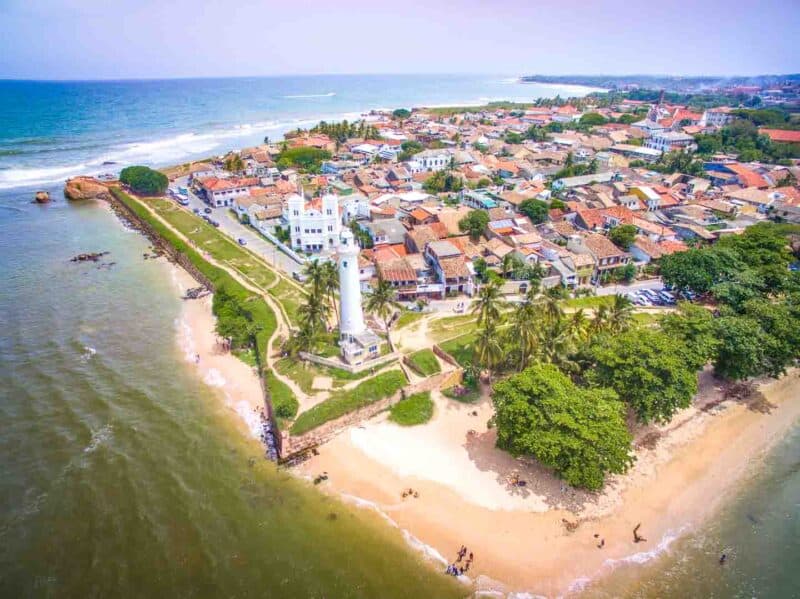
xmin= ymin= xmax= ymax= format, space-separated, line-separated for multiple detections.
xmin=165 ymin=263 xmax=264 ymax=439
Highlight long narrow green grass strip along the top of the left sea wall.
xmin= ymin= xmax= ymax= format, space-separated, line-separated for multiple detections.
xmin=111 ymin=187 xmax=298 ymax=419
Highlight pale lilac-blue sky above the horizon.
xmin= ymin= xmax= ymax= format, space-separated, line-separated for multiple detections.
xmin=0 ymin=0 xmax=800 ymax=79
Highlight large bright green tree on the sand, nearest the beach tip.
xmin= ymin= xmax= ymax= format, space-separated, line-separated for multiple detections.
xmin=492 ymin=364 xmax=633 ymax=490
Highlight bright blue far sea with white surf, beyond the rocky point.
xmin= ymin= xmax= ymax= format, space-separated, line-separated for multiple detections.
xmin=0 ymin=75 xmax=600 ymax=189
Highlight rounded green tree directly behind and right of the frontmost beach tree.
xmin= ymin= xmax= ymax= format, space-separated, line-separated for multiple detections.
xmin=587 ymin=328 xmax=697 ymax=423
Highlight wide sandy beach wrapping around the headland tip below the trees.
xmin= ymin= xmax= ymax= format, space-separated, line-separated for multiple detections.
xmin=297 ymin=371 xmax=800 ymax=596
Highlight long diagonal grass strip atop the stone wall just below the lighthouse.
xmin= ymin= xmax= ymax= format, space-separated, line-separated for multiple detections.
xmin=289 ymin=370 xmax=406 ymax=435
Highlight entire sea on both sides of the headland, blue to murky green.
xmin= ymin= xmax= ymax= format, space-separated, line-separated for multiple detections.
xmin=0 ymin=76 xmax=800 ymax=598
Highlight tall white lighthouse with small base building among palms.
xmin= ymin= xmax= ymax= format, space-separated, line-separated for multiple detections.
xmin=337 ymin=229 xmax=382 ymax=365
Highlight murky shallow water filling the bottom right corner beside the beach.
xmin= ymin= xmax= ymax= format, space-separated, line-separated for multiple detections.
xmin=581 ymin=426 xmax=800 ymax=599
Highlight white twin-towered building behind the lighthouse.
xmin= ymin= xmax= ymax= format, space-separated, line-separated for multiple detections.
xmin=283 ymin=194 xmax=342 ymax=252
